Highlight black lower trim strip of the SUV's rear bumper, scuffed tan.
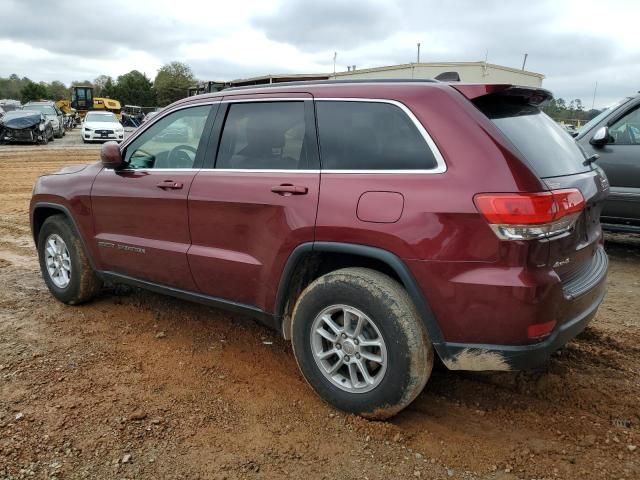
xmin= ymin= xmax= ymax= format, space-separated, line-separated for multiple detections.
xmin=439 ymin=279 xmax=606 ymax=370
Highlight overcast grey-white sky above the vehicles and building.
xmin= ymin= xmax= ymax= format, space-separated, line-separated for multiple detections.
xmin=0 ymin=0 xmax=640 ymax=108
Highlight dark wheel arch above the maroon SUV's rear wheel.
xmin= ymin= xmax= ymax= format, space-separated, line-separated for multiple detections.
xmin=275 ymin=242 xmax=444 ymax=350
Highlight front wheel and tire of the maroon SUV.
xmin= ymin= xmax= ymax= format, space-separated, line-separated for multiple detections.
xmin=38 ymin=215 xmax=102 ymax=305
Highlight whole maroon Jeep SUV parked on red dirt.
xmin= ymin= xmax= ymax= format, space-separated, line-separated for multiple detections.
xmin=31 ymin=81 xmax=608 ymax=418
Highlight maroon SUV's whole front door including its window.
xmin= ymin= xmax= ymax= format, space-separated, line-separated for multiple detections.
xmin=91 ymin=105 xmax=216 ymax=290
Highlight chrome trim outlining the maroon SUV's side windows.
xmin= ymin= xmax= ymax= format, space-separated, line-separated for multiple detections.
xmin=116 ymin=97 xmax=447 ymax=175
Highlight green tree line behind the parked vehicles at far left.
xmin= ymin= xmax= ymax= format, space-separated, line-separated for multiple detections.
xmin=0 ymin=62 xmax=196 ymax=107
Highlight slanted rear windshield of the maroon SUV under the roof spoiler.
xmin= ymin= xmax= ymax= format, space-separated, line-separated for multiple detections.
xmin=474 ymin=95 xmax=590 ymax=178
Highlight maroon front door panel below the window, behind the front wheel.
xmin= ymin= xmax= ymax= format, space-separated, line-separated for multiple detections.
xmin=91 ymin=169 xmax=196 ymax=290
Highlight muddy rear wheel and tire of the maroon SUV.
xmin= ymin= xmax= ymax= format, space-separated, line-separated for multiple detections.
xmin=291 ymin=267 xmax=434 ymax=419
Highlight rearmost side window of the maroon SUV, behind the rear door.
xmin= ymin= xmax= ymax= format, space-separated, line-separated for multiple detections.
xmin=316 ymin=100 xmax=437 ymax=170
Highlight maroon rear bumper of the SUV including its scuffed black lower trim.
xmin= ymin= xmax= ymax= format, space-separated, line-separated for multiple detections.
xmin=412 ymin=245 xmax=609 ymax=371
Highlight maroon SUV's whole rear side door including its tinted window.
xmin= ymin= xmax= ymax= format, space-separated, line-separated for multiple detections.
xmin=188 ymin=94 xmax=320 ymax=311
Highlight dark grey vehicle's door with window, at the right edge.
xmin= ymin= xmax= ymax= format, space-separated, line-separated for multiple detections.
xmin=596 ymin=106 xmax=640 ymax=225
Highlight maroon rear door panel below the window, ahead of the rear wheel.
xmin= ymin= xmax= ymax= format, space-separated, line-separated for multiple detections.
xmin=188 ymin=170 xmax=319 ymax=311
